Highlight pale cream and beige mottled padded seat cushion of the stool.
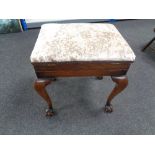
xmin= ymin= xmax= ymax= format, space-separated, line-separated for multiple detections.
xmin=30 ymin=23 xmax=135 ymax=62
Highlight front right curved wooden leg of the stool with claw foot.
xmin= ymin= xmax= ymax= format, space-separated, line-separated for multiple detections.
xmin=104 ymin=76 xmax=128 ymax=113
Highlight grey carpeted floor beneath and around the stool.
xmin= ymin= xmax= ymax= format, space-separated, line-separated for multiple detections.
xmin=0 ymin=20 xmax=155 ymax=135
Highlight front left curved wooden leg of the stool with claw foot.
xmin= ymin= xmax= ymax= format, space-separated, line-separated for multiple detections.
xmin=34 ymin=79 xmax=54 ymax=116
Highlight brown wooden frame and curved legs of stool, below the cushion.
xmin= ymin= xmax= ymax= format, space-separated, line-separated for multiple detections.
xmin=32 ymin=61 xmax=132 ymax=116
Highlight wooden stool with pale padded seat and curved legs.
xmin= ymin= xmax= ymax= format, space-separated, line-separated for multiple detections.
xmin=30 ymin=23 xmax=135 ymax=116
